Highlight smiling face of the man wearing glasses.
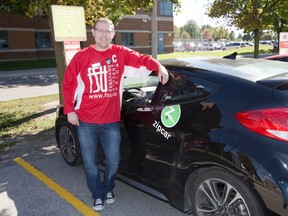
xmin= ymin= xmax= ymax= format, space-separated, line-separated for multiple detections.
xmin=92 ymin=22 xmax=115 ymax=51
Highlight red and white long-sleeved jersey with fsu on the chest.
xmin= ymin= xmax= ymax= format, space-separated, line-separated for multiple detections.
xmin=62 ymin=44 xmax=160 ymax=124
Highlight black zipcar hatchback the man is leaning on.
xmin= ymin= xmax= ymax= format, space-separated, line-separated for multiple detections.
xmin=56 ymin=57 xmax=288 ymax=216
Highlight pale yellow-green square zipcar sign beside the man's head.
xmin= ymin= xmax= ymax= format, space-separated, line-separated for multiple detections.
xmin=51 ymin=5 xmax=87 ymax=41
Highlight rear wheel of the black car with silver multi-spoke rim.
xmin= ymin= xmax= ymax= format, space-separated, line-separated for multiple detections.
xmin=189 ymin=168 xmax=265 ymax=216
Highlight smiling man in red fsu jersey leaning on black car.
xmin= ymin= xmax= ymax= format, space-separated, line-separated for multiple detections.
xmin=62 ymin=18 xmax=169 ymax=211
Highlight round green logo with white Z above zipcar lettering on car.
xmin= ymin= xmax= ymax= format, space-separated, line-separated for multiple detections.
xmin=161 ymin=104 xmax=181 ymax=128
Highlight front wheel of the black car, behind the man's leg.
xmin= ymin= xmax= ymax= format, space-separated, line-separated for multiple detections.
xmin=56 ymin=121 xmax=82 ymax=166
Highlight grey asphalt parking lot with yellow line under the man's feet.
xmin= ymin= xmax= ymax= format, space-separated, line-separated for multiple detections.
xmin=0 ymin=150 xmax=186 ymax=216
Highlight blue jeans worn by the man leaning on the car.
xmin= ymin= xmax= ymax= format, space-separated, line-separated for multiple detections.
xmin=77 ymin=121 xmax=121 ymax=199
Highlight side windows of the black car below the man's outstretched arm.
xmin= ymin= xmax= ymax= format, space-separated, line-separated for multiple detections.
xmin=123 ymin=70 xmax=218 ymax=106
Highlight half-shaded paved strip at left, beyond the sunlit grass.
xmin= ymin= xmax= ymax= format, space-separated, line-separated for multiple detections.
xmin=0 ymin=68 xmax=59 ymax=101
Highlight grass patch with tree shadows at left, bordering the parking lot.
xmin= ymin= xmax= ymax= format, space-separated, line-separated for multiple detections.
xmin=0 ymin=94 xmax=59 ymax=150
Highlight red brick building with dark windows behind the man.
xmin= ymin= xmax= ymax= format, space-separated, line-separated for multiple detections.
xmin=0 ymin=0 xmax=173 ymax=61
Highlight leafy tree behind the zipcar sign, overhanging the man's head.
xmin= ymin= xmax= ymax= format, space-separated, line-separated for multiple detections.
xmin=0 ymin=0 xmax=181 ymax=103
